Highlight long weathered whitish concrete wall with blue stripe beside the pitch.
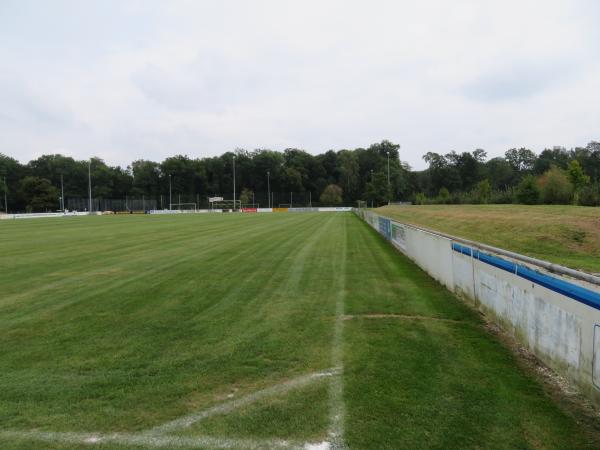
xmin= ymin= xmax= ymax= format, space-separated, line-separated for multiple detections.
xmin=358 ymin=211 xmax=600 ymax=405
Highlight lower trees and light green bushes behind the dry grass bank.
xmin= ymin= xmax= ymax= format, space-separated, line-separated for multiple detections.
xmin=413 ymin=141 xmax=600 ymax=206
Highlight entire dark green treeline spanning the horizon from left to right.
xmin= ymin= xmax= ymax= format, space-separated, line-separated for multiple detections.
xmin=0 ymin=141 xmax=600 ymax=212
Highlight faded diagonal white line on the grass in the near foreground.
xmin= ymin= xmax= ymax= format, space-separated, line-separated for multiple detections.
xmin=149 ymin=369 xmax=339 ymax=434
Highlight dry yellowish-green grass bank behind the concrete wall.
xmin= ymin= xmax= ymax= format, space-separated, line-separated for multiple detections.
xmin=376 ymin=205 xmax=600 ymax=273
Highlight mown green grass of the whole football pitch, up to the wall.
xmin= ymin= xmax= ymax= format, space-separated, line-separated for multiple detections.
xmin=0 ymin=213 xmax=598 ymax=449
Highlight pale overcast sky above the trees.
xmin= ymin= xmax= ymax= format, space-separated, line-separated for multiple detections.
xmin=0 ymin=0 xmax=600 ymax=169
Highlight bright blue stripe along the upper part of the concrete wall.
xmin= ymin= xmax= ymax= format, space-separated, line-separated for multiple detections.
xmin=452 ymin=242 xmax=600 ymax=310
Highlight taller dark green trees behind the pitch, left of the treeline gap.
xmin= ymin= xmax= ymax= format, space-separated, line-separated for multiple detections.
xmin=0 ymin=141 xmax=410 ymax=211
